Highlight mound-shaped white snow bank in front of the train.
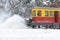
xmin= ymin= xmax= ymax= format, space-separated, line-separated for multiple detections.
xmin=0 ymin=15 xmax=27 ymax=29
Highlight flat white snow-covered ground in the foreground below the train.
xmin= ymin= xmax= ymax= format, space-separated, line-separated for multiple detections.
xmin=0 ymin=29 xmax=60 ymax=40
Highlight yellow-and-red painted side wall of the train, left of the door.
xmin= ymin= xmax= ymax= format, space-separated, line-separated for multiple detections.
xmin=32 ymin=8 xmax=55 ymax=23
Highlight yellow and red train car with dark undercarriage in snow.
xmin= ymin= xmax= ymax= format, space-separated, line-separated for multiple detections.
xmin=27 ymin=7 xmax=60 ymax=29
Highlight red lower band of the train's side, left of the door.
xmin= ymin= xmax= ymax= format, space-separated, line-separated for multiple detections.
xmin=32 ymin=17 xmax=55 ymax=23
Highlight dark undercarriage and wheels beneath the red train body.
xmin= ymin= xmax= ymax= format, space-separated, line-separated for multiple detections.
xmin=27 ymin=22 xmax=60 ymax=29
